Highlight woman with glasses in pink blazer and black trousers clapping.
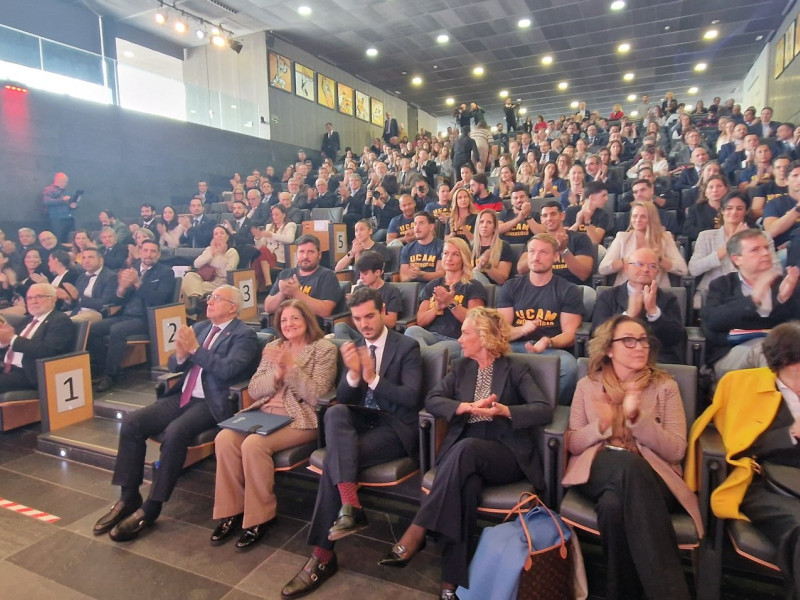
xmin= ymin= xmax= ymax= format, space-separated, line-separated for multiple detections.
xmin=563 ymin=315 xmax=702 ymax=600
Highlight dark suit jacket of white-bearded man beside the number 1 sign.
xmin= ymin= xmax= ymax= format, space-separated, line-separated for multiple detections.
xmin=0 ymin=310 xmax=76 ymax=389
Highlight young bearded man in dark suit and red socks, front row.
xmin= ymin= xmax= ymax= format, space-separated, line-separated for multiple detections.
xmin=281 ymin=286 xmax=422 ymax=598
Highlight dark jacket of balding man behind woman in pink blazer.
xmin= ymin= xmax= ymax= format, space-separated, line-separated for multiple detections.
xmin=592 ymin=283 xmax=684 ymax=364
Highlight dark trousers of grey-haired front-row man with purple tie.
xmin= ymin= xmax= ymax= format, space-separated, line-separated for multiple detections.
xmin=111 ymin=395 xmax=217 ymax=502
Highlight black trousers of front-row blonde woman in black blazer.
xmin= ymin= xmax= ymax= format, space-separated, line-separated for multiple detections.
xmin=414 ymin=424 xmax=525 ymax=587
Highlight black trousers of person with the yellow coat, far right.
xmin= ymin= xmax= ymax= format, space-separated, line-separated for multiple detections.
xmin=739 ymin=475 xmax=800 ymax=599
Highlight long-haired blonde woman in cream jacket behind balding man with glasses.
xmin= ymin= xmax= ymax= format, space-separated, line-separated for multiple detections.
xmin=597 ymin=202 xmax=689 ymax=288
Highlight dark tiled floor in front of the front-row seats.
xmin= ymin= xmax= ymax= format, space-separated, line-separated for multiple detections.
xmin=0 ymin=368 xmax=782 ymax=600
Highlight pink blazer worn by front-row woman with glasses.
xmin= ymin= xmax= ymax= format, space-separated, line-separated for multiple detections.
xmin=562 ymin=377 xmax=703 ymax=536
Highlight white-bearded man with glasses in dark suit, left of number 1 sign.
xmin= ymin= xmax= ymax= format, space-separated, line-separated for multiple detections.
xmin=0 ymin=283 xmax=75 ymax=393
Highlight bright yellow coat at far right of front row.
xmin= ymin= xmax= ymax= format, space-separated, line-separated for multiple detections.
xmin=684 ymin=367 xmax=783 ymax=521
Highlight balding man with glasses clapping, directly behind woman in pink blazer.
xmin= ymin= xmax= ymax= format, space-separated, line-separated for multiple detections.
xmin=592 ymin=248 xmax=684 ymax=364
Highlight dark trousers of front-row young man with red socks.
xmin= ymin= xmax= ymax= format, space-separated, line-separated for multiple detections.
xmin=308 ymin=404 xmax=408 ymax=550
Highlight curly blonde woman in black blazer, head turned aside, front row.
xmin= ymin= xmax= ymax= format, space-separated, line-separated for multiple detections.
xmin=380 ymin=306 xmax=553 ymax=600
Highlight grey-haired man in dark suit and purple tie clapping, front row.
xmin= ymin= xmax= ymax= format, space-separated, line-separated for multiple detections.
xmin=93 ymin=285 xmax=259 ymax=542
